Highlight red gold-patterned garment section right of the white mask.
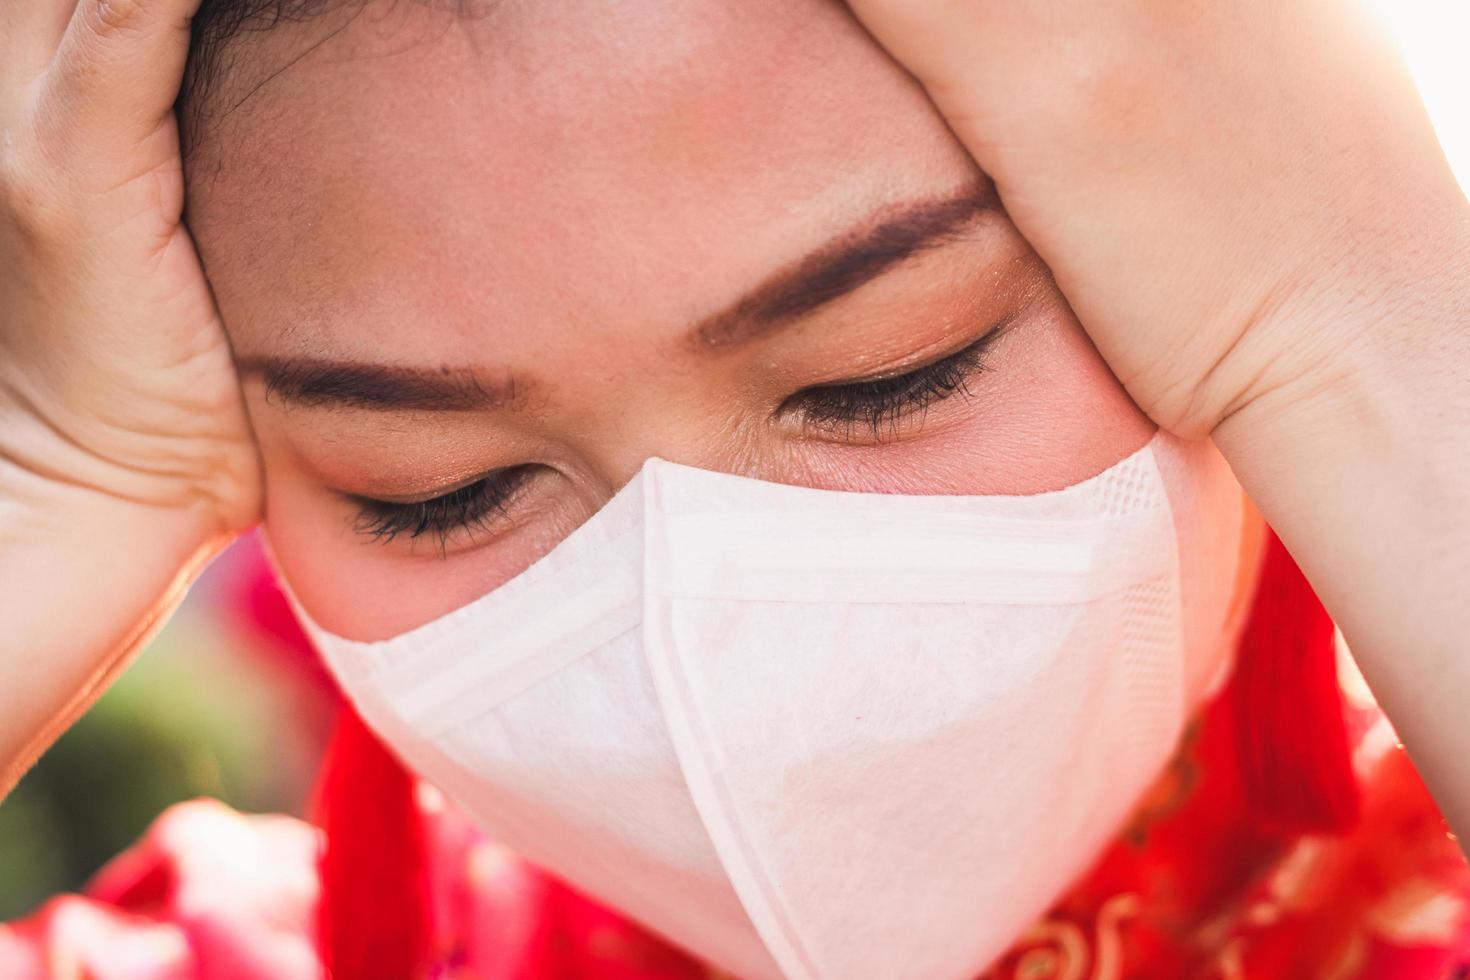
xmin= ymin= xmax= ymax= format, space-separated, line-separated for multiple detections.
xmin=986 ymin=667 xmax=1470 ymax=980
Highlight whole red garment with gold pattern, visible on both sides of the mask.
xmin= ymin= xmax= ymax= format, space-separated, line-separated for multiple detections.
xmin=0 ymin=658 xmax=1470 ymax=980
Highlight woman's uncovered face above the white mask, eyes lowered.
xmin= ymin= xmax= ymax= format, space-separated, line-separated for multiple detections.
xmin=188 ymin=0 xmax=1154 ymax=639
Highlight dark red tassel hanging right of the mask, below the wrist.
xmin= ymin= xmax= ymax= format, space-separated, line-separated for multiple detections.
xmin=1227 ymin=532 xmax=1360 ymax=836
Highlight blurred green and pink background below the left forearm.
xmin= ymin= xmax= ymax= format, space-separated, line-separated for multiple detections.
xmin=0 ymin=539 xmax=331 ymax=921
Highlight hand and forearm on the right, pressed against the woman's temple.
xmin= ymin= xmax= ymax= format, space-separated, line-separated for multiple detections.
xmin=851 ymin=0 xmax=1470 ymax=839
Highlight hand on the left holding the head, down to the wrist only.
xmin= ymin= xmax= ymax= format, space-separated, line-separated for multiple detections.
xmin=0 ymin=0 xmax=260 ymax=532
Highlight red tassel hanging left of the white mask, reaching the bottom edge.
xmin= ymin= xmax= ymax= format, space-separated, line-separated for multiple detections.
xmin=313 ymin=701 xmax=432 ymax=980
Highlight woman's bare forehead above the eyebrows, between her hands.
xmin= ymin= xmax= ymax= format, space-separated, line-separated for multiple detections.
xmin=190 ymin=0 xmax=973 ymax=360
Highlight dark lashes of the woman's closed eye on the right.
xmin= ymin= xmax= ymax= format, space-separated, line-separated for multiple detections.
xmin=782 ymin=331 xmax=1000 ymax=439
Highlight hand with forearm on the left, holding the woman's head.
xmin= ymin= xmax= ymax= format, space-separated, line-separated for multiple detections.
xmin=0 ymin=0 xmax=260 ymax=796
